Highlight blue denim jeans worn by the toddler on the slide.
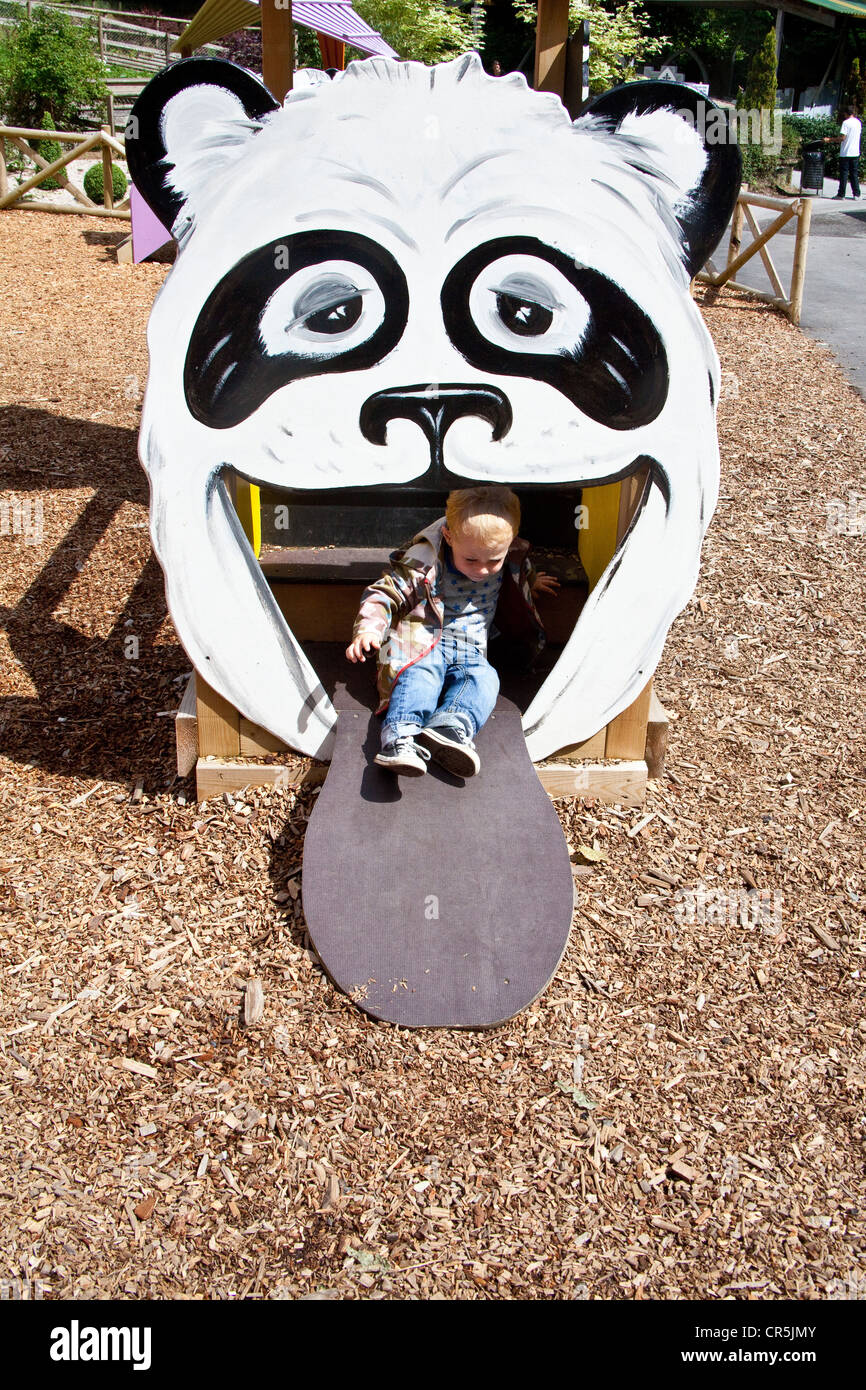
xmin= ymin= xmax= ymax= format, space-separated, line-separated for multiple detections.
xmin=382 ymin=641 xmax=499 ymax=748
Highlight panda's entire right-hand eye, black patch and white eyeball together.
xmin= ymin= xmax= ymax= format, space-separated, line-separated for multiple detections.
xmin=441 ymin=236 xmax=669 ymax=430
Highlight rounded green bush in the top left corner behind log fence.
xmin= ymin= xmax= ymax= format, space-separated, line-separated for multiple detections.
xmin=0 ymin=10 xmax=107 ymax=131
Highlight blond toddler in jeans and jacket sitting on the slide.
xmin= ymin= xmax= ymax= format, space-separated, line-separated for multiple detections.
xmin=346 ymin=487 xmax=559 ymax=777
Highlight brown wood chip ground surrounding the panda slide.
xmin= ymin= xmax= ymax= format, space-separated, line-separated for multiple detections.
xmin=0 ymin=213 xmax=866 ymax=1301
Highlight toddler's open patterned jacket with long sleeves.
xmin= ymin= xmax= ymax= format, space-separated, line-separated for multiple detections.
xmin=352 ymin=517 xmax=545 ymax=714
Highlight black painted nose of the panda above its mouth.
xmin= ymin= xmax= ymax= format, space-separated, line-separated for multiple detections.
xmin=359 ymin=382 xmax=512 ymax=474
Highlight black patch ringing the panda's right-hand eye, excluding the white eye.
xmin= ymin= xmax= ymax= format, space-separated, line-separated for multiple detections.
xmin=442 ymin=236 xmax=669 ymax=430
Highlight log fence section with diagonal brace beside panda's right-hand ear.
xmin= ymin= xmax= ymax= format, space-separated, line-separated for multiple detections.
xmin=698 ymin=193 xmax=812 ymax=324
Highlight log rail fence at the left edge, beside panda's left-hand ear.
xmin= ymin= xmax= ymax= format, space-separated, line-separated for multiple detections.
xmin=0 ymin=125 xmax=129 ymax=221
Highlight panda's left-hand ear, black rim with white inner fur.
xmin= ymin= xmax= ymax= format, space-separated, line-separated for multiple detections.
xmin=126 ymin=58 xmax=279 ymax=227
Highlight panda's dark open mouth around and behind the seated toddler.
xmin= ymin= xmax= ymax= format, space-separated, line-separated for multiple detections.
xmin=222 ymin=456 xmax=670 ymax=737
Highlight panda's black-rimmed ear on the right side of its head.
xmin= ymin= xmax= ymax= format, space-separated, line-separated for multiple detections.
xmin=581 ymin=82 xmax=742 ymax=277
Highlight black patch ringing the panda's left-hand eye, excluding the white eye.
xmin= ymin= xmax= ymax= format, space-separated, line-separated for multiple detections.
xmin=183 ymin=231 xmax=409 ymax=430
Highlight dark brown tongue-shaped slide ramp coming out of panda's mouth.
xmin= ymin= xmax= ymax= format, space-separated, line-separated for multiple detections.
xmin=303 ymin=698 xmax=574 ymax=1029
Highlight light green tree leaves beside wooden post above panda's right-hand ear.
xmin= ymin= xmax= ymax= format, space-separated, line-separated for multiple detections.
xmin=514 ymin=0 xmax=669 ymax=95
